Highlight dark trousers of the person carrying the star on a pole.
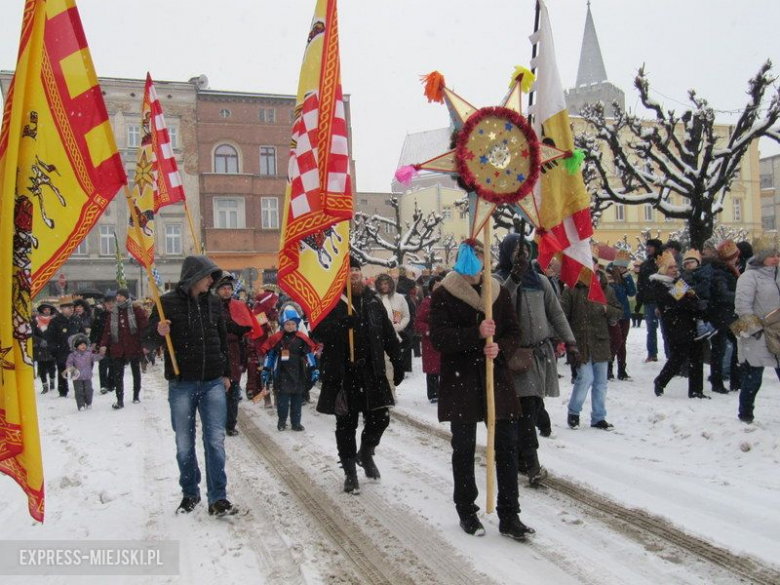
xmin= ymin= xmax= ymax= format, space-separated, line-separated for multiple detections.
xmin=450 ymin=420 xmax=520 ymax=518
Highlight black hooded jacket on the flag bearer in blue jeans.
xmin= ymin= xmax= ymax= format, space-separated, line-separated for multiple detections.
xmin=143 ymin=256 xmax=230 ymax=381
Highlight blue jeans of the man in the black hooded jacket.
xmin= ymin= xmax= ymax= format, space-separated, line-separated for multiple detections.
xmin=168 ymin=378 xmax=227 ymax=504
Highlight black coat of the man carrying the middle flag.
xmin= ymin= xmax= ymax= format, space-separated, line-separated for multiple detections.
xmin=312 ymin=288 xmax=403 ymax=414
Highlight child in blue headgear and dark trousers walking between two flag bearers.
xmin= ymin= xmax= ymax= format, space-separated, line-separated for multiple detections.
xmin=260 ymin=306 xmax=319 ymax=431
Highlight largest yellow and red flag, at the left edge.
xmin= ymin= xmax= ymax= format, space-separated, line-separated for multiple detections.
xmin=0 ymin=0 xmax=127 ymax=521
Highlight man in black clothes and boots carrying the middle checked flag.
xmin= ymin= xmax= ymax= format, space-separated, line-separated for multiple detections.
xmin=312 ymin=258 xmax=404 ymax=494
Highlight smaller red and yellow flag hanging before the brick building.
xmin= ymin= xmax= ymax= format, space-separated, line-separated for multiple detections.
xmin=127 ymin=73 xmax=184 ymax=266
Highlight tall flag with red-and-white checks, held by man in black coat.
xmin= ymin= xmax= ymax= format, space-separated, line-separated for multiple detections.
xmin=279 ymin=0 xmax=352 ymax=328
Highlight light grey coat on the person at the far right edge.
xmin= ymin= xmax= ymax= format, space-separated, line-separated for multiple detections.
xmin=734 ymin=263 xmax=780 ymax=368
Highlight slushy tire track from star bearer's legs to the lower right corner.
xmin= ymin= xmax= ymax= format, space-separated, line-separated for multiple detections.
xmin=391 ymin=409 xmax=780 ymax=585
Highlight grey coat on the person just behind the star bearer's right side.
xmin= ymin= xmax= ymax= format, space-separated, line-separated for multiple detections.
xmin=504 ymin=275 xmax=574 ymax=398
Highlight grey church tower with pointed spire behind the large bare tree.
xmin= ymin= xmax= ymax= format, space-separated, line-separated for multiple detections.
xmin=566 ymin=0 xmax=626 ymax=116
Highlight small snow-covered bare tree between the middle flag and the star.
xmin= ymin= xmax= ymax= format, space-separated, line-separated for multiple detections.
xmin=350 ymin=195 xmax=442 ymax=268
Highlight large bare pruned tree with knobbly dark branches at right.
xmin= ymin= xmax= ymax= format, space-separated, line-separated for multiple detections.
xmin=576 ymin=61 xmax=780 ymax=248
